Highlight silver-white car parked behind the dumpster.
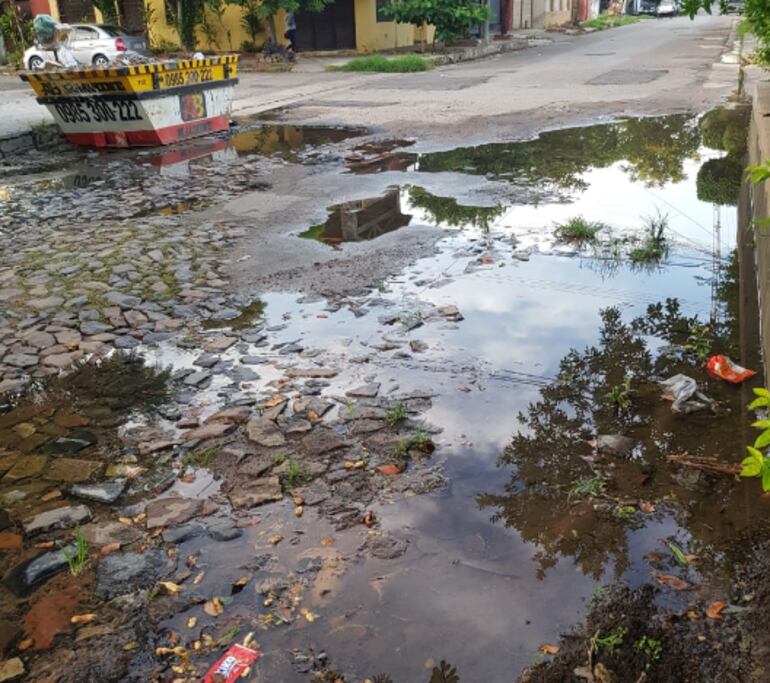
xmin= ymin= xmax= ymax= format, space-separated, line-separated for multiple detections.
xmin=24 ymin=24 xmax=152 ymax=71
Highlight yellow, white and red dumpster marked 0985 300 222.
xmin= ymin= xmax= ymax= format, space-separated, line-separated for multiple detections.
xmin=21 ymin=55 xmax=238 ymax=147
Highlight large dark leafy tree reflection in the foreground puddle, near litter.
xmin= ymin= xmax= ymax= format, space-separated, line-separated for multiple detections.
xmin=477 ymin=268 xmax=752 ymax=579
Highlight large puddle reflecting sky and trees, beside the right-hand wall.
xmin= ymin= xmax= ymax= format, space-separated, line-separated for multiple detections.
xmin=3 ymin=107 xmax=768 ymax=683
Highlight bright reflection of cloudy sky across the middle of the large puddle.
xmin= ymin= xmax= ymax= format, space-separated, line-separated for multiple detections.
xmin=140 ymin=127 xmax=736 ymax=683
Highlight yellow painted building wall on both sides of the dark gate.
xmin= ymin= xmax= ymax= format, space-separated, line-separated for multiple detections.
xmin=145 ymin=0 xmax=424 ymax=52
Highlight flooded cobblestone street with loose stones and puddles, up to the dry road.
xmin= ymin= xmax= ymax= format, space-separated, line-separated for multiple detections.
xmin=0 ymin=93 xmax=769 ymax=683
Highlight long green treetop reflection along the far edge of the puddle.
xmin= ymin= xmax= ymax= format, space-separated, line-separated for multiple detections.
xmin=419 ymin=114 xmax=701 ymax=196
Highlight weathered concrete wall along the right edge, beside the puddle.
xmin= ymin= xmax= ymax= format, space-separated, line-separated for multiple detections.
xmin=739 ymin=83 xmax=770 ymax=386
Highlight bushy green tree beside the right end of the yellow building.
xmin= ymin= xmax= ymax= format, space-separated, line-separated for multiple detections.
xmin=383 ymin=0 xmax=491 ymax=43
